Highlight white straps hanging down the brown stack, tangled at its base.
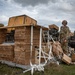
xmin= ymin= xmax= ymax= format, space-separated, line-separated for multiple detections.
xmin=23 ymin=26 xmax=54 ymax=75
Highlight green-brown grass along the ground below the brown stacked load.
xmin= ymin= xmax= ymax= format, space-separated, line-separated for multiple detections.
xmin=0 ymin=63 xmax=75 ymax=75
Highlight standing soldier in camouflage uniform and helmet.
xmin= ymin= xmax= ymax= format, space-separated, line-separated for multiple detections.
xmin=60 ymin=20 xmax=70 ymax=54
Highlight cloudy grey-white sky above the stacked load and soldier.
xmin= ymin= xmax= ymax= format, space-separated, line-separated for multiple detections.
xmin=0 ymin=0 xmax=75 ymax=32
